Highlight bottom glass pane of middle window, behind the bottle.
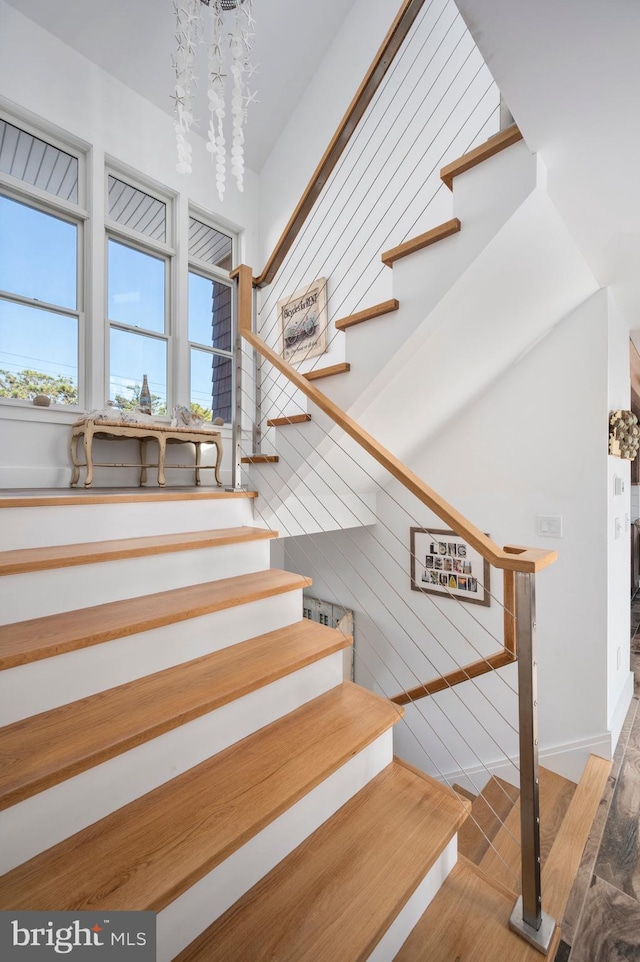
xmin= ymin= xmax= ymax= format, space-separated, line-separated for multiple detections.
xmin=109 ymin=327 xmax=167 ymax=414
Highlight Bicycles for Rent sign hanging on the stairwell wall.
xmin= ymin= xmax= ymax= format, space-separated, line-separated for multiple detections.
xmin=278 ymin=277 xmax=328 ymax=364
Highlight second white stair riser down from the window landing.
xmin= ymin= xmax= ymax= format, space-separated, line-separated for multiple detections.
xmin=0 ymin=539 xmax=270 ymax=624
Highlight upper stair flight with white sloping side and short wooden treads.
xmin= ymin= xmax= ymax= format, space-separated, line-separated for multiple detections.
xmin=249 ymin=127 xmax=598 ymax=535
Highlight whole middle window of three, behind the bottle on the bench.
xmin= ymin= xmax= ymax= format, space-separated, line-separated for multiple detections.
xmin=107 ymin=174 xmax=172 ymax=414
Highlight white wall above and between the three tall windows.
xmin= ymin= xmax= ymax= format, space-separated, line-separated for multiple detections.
xmin=0 ymin=0 xmax=259 ymax=487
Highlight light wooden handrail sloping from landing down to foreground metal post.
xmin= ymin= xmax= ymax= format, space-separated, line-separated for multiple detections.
xmin=231 ymin=264 xmax=557 ymax=573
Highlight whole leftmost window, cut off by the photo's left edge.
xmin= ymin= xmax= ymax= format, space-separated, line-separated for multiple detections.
xmin=0 ymin=119 xmax=83 ymax=405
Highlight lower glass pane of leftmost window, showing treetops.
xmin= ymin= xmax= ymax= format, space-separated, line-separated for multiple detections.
xmin=0 ymin=300 xmax=78 ymax=404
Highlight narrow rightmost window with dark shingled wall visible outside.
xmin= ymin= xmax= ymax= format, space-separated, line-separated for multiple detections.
xmin=188 ymin=217 xmax=233 ymax=423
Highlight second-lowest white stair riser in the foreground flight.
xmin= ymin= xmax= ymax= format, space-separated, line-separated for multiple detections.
xmin=157 ymin=731 xmax=393 ymax=962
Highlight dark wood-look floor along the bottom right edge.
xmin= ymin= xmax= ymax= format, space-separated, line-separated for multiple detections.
xmin=555 ymin=593 xmax=640 ymax=962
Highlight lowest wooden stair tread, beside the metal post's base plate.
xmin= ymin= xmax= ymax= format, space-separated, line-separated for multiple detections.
xmin=394 ymin=856 xmax=560 ymax=962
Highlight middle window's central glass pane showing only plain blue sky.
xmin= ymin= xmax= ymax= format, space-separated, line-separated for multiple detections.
xmin=108 ymin=240 xmax=166 ymax=334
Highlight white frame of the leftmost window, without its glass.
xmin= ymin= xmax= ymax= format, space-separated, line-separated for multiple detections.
xmin=0 ymin=109 xmax=90 ymax=415
